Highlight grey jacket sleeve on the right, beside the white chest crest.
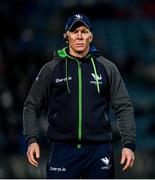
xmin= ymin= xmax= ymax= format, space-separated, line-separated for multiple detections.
xmin=109 ymin=64 xmax=136 ymax=151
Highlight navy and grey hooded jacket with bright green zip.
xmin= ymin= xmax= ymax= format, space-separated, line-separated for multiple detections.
xmin=23 ymin=48 xmax=135 ymax=150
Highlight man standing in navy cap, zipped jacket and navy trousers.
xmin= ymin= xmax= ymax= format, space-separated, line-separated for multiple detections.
xmin=23 ymin=14 xmax=135 ymax=179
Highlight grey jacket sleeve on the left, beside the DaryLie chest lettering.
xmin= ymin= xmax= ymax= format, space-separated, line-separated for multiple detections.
xmin=23 ymin=64 xmax=51 ymax=145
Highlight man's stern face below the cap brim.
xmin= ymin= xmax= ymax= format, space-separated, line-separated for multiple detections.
xmin=67 ymin=25 xmax=93 ymax=56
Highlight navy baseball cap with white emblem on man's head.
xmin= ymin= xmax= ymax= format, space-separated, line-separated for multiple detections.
xmin=65 ymin=13 xmax=91 ymax=32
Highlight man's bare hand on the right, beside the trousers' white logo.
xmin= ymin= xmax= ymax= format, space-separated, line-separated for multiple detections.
xmin=121 ymin=148 xmax=135 ymax=171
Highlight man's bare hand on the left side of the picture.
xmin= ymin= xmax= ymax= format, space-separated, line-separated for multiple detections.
xmin=27 ymin=143 xmax=40 ymax=166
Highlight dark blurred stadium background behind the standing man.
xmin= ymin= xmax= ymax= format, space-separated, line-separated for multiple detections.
xmin=0 ymin=0 xmax=155 ymax=178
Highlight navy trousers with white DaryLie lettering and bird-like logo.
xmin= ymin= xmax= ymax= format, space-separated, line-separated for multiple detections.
xmin=46 ymin=142 xmax=114 ymax=179
